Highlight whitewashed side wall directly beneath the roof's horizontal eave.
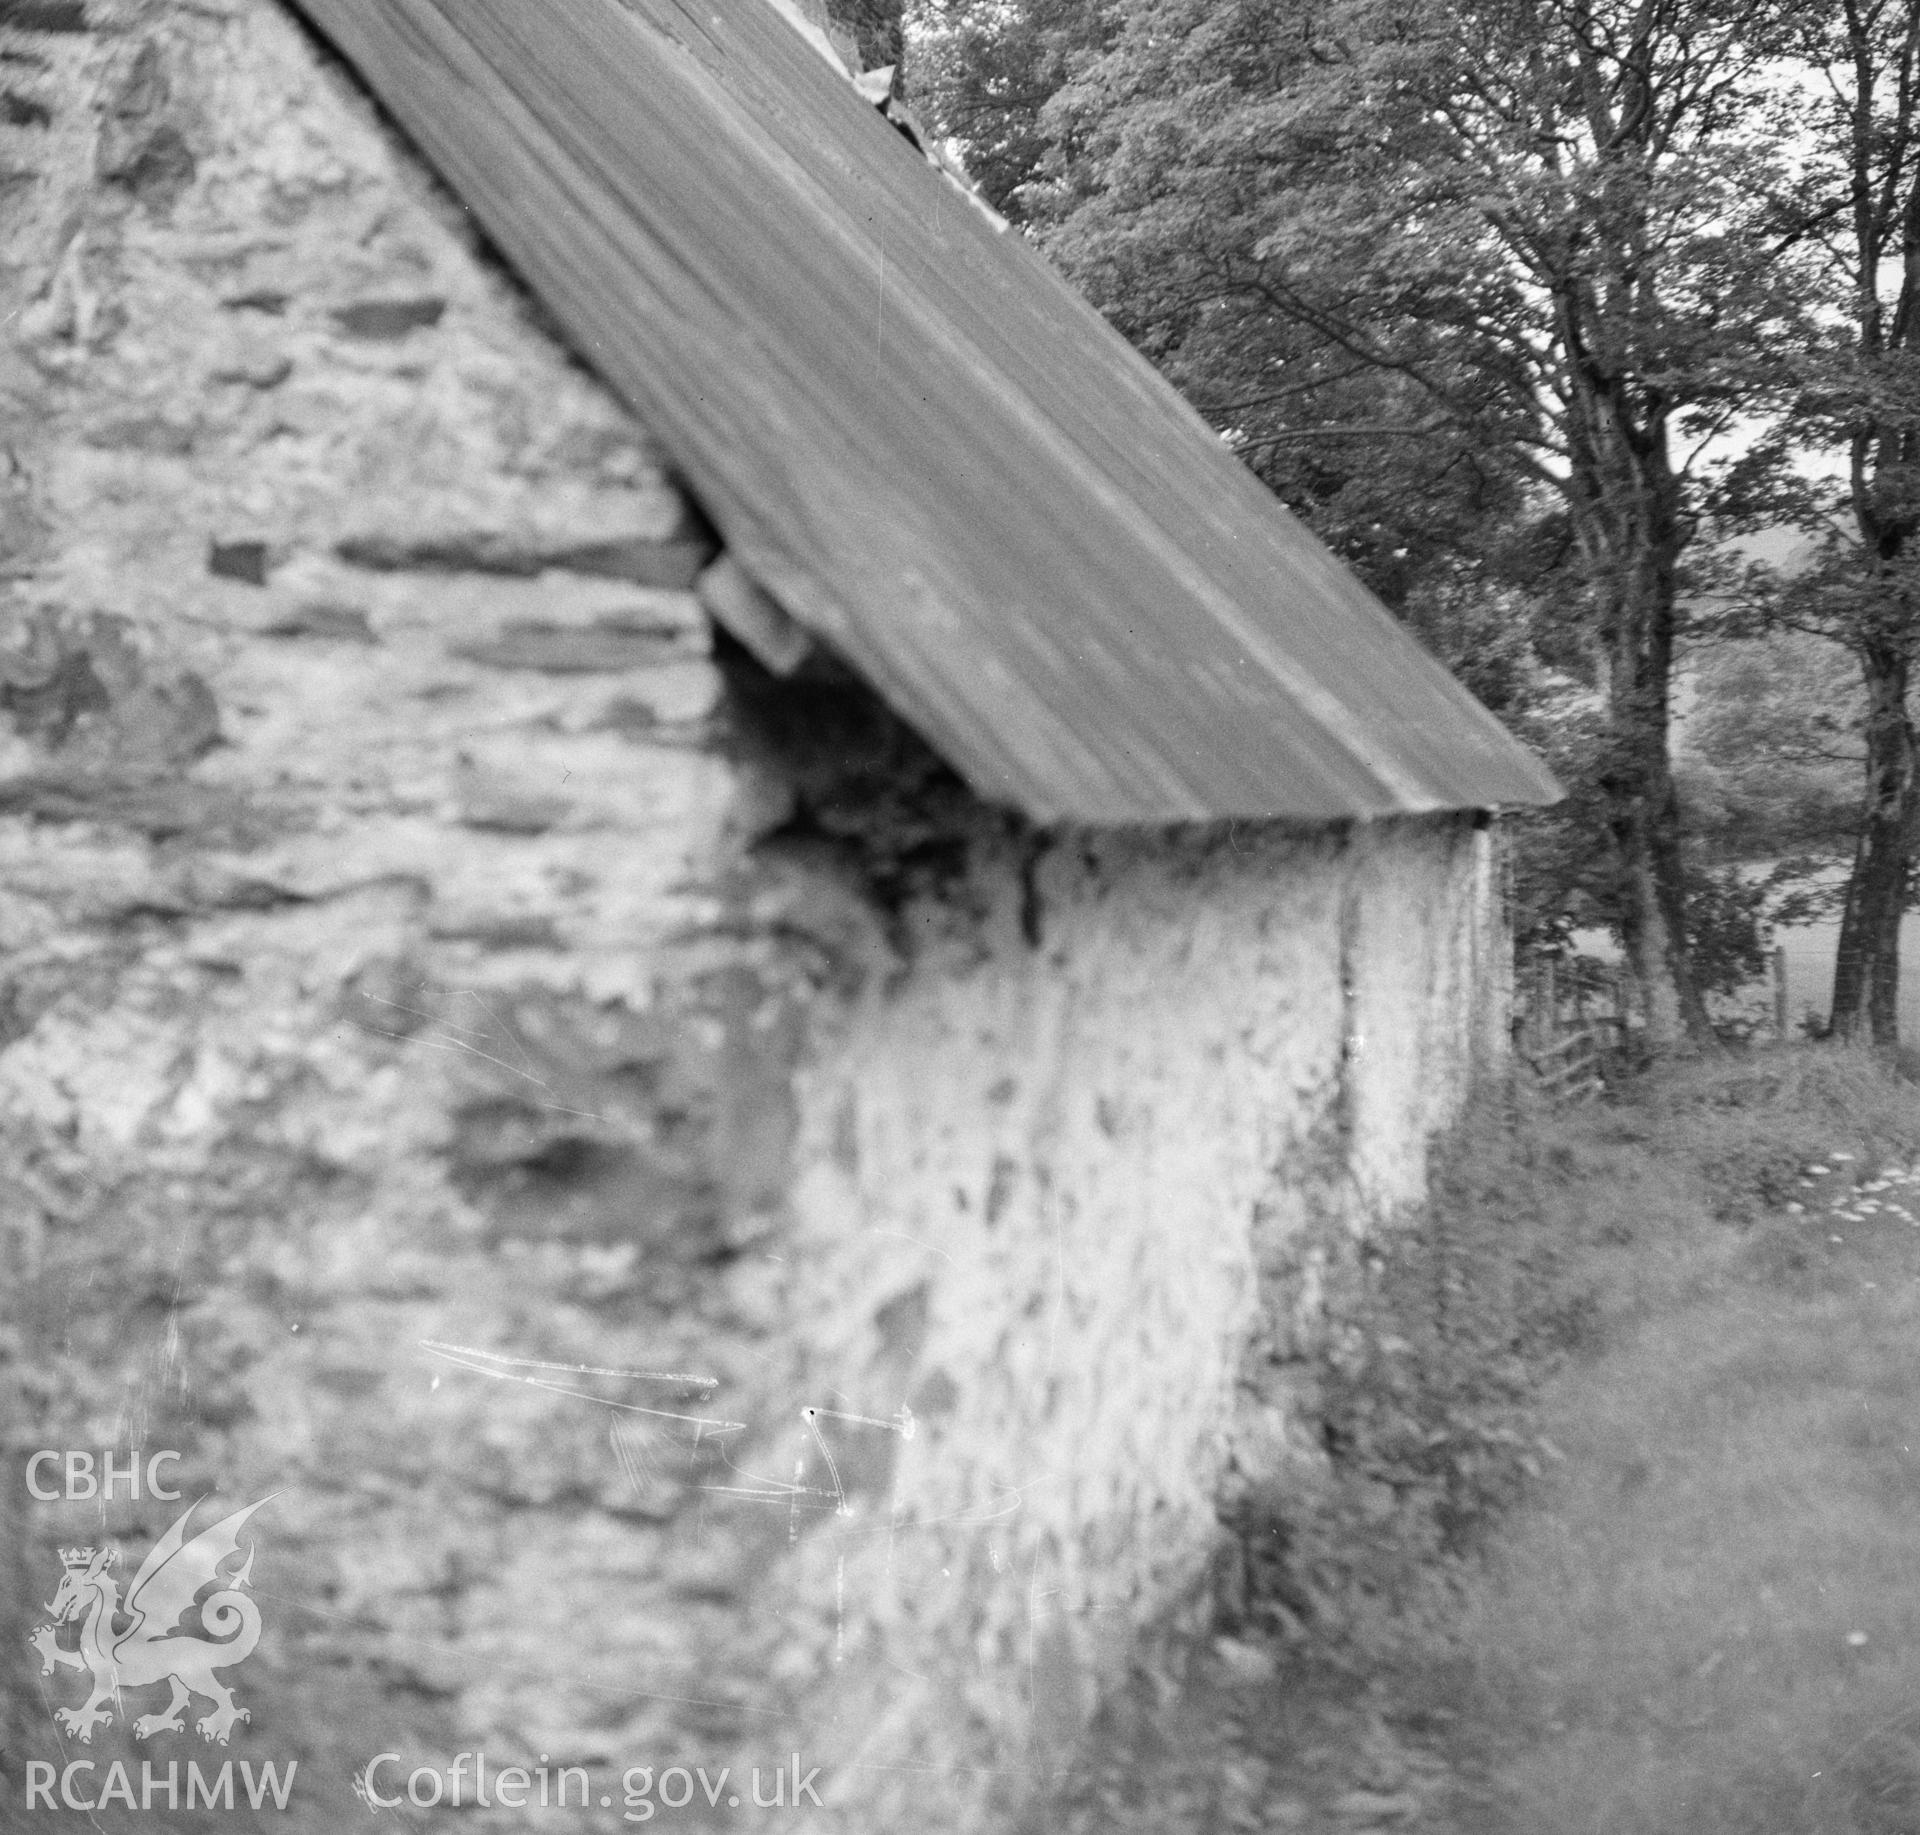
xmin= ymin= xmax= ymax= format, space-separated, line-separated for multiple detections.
xmin=768 ymin=823 xmax=1488 ymax=1825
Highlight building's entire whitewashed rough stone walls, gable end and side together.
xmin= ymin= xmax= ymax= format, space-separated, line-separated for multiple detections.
xmin=0 ymin=0 xmax=1501 ymax=1831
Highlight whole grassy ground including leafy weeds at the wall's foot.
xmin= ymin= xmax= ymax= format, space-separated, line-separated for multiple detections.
xmin=1044 ymin=1046 xmax=1920 ymax=1835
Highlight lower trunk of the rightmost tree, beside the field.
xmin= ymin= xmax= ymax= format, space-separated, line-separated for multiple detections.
xmin=1828 ymin=639 xmax=1920 ymax=1046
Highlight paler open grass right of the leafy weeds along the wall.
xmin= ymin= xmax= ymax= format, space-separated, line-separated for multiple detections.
xmin=1450 ymin=1050 xmax=1920 ymax=1835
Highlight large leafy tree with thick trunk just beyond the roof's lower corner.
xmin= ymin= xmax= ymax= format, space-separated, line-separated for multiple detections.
xmin=917 ymin=0 xmax=1799 ymax=1044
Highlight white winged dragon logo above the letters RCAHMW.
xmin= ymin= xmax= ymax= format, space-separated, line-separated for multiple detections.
xmin=27 ymin=1497 xmax=273 ymax=1745
